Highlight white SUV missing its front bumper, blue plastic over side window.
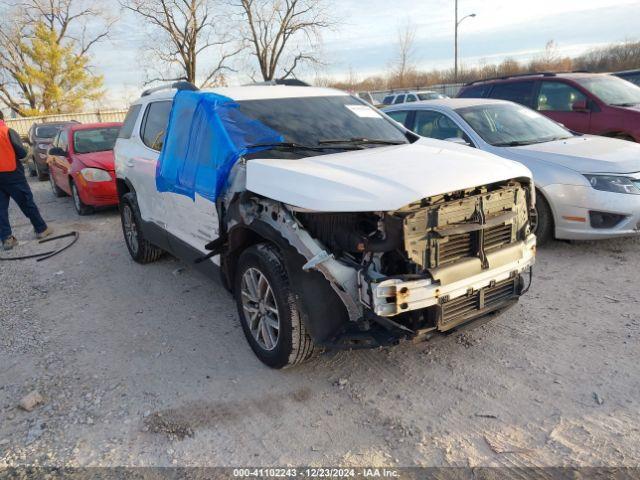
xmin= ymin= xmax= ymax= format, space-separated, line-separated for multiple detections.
xmin=115 ymin=84 xmax=536 ymax=368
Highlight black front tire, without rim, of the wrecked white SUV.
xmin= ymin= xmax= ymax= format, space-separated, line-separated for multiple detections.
xmin=235 ymin=243 xmax=315 ymax=369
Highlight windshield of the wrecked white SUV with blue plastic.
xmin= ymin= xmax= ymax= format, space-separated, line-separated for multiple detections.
xmin=238 ymin=95 xmax=408 ymax=153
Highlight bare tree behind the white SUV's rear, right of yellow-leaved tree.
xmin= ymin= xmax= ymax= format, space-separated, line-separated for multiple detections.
xmin=121 ymin=0 xmax=242 ymax=87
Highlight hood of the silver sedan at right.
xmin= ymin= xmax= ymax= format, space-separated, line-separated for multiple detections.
xmin=506 ymin=135 xmax=640 ymax=173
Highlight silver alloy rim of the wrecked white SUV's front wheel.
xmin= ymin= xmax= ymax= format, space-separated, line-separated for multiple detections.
xmin=241 ymin=268 xmax=280 ymax=352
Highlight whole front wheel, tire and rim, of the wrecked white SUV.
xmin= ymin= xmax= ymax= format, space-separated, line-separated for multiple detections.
xmin=235 ymin=243 xmax=315 ymax=369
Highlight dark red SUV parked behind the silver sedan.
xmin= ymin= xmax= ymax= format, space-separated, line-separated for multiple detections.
xmin=458 ymin=73 xmax=640 ymax=142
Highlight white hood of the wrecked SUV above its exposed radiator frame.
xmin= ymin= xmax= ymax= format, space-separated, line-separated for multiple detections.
xmin=247 ymin=140 xmax=531 ymax=212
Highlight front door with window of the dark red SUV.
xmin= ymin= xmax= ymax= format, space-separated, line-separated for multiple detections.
xmin=535 ymin=80 xmax=591 ymax=133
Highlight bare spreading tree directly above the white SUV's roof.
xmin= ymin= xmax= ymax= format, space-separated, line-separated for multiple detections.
xmin=232 ymin=0 xmax=334 ymax=81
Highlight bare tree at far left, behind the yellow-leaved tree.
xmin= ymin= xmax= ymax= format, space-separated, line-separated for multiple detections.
xmin=0 ymin=0 xmax=113 ymax=114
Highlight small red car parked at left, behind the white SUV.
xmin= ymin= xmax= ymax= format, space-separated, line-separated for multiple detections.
xmin=47 ymin=123 xmax=122 ymax=215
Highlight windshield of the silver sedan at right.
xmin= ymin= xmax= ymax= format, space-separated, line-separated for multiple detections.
xmin=456 ymin=104 xmax=573 ymax=147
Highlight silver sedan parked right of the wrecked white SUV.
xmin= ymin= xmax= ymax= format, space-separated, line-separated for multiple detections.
xmin=384 ymin=99 xmax=640 ymax=243
